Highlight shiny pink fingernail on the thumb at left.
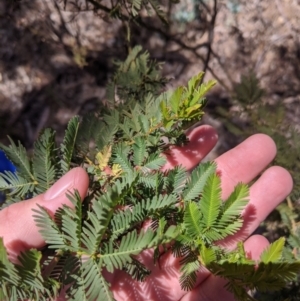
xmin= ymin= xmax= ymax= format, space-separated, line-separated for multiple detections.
xmin=44 ymin=171 xmax=77 ymax=201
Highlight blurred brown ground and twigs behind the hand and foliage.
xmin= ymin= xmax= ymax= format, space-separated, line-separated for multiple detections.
xmin=0 ymin=0 xmax=300 ymax=301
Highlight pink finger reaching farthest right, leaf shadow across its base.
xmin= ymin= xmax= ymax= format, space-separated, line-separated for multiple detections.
xmin=220 ymin=166 xmax=293 ymax=249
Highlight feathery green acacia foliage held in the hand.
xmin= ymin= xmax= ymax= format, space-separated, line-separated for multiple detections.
xmin=0 ymin=73 xmax=300 ymax=300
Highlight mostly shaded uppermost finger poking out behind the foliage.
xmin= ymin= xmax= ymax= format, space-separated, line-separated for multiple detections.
xmin=163 ymin=125 xmax=218 ymax=171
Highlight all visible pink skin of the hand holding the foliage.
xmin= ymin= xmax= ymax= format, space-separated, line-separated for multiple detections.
xmin=0 ymin=126 xmax=293 ymax=301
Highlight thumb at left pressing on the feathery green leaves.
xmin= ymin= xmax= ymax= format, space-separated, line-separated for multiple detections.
xmin=0 ymin=167 xmax=89 ymax=260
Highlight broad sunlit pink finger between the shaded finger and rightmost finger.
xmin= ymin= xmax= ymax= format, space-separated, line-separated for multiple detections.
xmin=215 ymin=134 xmax=276 ymax=199
